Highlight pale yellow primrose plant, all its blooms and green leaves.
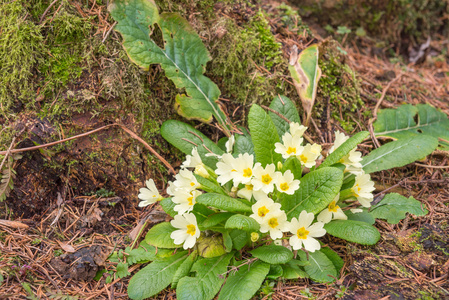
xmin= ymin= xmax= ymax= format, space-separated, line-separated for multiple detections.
xmin=119 ymin=97 xmax=428 ymax=299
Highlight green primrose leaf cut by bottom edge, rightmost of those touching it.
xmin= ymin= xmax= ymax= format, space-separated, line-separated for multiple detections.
xmin=218 ymin=260 xmax=270 ymax=300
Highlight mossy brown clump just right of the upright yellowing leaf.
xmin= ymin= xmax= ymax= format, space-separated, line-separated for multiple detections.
xmin=315 ymin=41 xmax=363 ymax=131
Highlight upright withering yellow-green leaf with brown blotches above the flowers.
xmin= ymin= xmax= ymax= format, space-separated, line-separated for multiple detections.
xmin=288 ymin=44 xmax=321 ymax=124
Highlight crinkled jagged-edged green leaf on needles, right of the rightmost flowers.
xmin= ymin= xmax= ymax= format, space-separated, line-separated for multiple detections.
xmin=370 ymin=193 xmax=429 ymax=224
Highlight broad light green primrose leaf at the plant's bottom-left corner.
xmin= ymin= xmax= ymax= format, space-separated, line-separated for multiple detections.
xmin=128 ymin=251 xmax=187 ymax=300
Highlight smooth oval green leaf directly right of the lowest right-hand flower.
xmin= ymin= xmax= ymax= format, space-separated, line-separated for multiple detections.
xmin=324 ymin=220 xmax=380 ymax=245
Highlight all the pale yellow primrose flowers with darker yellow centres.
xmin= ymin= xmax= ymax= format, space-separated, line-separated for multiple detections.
xmin=139 ymin=123 xmax=374 ymax=252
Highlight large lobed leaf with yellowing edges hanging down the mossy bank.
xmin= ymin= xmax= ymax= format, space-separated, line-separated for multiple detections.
xmin=109 ymin=0 xmax=227 ymax=130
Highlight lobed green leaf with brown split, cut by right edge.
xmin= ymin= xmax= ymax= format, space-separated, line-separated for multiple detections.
xmin=373 ymin=104 xmax=449 ymax=150
